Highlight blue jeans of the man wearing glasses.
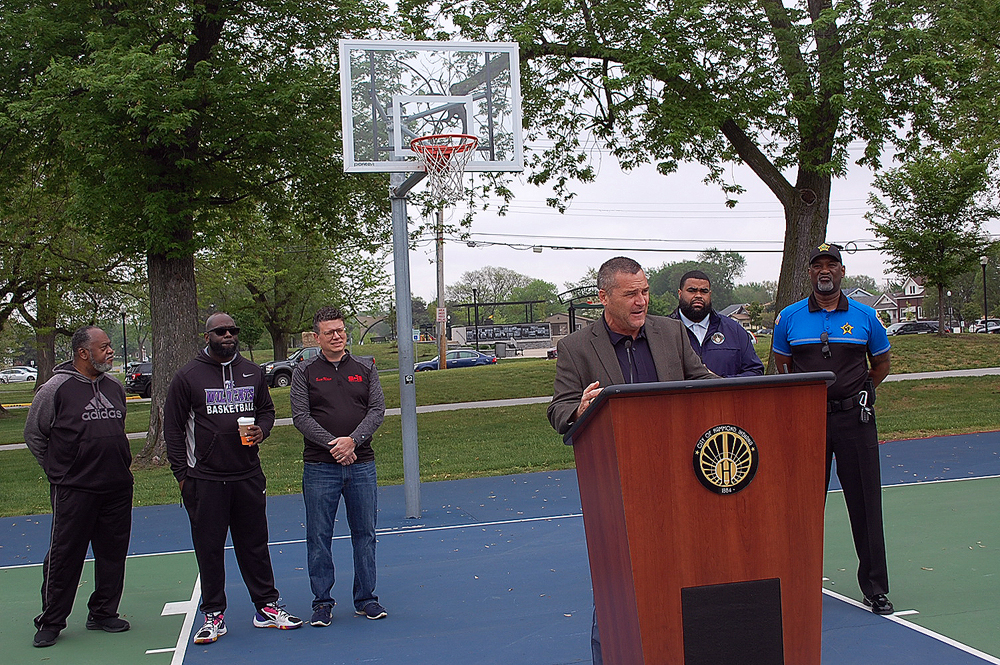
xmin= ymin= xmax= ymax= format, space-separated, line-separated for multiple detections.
xmin=302 ymin=461 xmax=378 ymax=610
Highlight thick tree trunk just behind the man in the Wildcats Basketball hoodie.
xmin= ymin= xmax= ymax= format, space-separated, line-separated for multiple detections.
xmin=135 ymin=254 xmax=202 ymax=465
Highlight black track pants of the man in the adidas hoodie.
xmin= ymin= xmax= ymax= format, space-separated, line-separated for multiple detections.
xmin=35 ymin=485 xmax=132 ymax=631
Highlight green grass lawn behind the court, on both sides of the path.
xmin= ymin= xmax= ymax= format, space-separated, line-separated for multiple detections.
xmin=0 ymin=335 xmax=1000 ymax=516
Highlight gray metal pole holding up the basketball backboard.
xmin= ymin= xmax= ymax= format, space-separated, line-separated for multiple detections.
xmin=389 ymin=171 xmax=425 ymax=518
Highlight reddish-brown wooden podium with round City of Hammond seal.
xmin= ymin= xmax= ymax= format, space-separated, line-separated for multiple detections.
xmin=565 ymin=372 xmax=834 ymax=665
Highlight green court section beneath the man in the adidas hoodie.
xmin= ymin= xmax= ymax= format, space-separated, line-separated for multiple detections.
xmin=0 ymin=553 xmax=198 ymax=665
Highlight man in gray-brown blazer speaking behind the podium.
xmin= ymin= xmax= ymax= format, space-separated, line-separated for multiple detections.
xmin=547 ymin=256 xmax=719 ymax=665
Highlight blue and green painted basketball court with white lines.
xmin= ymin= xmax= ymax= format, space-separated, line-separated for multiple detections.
xmin=0 ymin=433 xmax=1000 ymax=665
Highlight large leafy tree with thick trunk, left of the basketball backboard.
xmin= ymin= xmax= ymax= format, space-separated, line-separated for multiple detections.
xmin=0 ymin=0 xmax=386 ymax=463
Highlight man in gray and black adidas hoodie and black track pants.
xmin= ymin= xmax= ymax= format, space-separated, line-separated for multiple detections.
xmin=24 ymin=326 xmax=133 ymax=647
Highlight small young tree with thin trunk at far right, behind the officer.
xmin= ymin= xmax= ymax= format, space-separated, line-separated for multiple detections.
xmin=866 ymin=153 xmax=1000 ymax=335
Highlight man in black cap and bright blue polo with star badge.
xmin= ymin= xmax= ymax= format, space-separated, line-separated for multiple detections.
xmin=774 ymin=243 xmax=893 ymax=614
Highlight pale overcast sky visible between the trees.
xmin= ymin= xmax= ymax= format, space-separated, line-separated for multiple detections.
xmin=389 ymin=145 xmax=886 ymax=301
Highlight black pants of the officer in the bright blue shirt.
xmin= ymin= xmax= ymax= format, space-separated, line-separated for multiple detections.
xmin=826 ymin=406 xmax=889 ymax=598
